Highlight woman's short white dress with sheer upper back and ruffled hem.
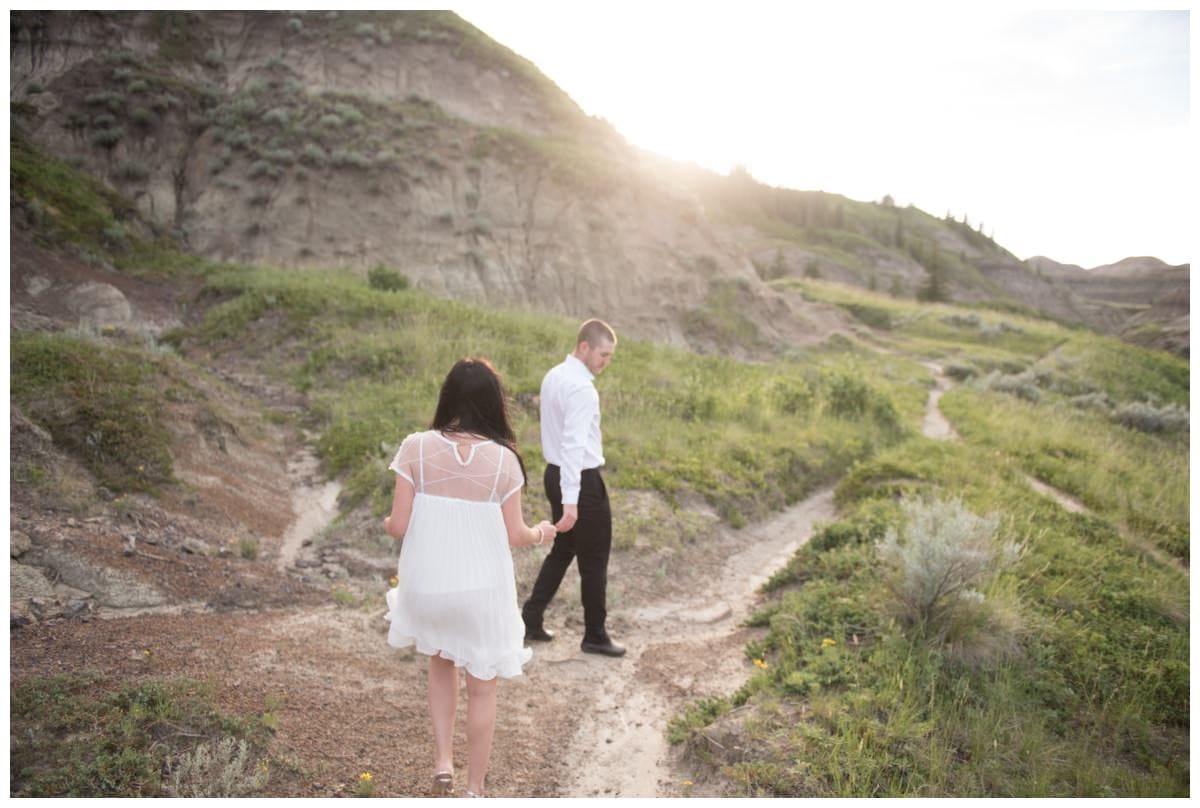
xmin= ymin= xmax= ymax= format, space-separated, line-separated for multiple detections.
xmin=388 ymin=431 xmax=533 ymax=680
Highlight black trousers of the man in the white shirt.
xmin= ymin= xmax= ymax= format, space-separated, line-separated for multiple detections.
xmin=521 ymin=465 xmax=612 ymax=640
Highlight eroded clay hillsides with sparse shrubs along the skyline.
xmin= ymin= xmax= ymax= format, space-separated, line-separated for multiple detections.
xmin=10 ymin=12 xmax=1187 ymax=354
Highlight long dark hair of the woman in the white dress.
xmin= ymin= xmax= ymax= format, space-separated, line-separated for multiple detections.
xmin=430 ymin=357 xmax=528 ymax=481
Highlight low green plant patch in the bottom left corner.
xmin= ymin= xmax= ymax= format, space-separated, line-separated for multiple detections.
xmin=10 ymin=672 xmax=268 ymax=797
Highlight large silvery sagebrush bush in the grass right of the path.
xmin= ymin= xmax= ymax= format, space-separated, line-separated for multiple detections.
xmin=875 ymin=499 xmax=1021 ymax=642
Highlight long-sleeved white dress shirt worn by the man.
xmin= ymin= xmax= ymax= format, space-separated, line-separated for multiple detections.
xmin=540 ymin=354 xmax=604 ymax=505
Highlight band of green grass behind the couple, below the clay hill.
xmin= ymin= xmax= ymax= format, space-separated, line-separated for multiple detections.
xmin=164 ymin=268 xmax=928 ymax=538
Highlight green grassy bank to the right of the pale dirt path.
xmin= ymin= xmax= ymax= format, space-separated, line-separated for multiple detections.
xmin=671 ymin=321 xmax=1190 ymax=797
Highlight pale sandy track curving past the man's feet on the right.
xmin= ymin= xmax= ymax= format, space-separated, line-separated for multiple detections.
xmin=549 ymin=489 xmax=834 ymax=797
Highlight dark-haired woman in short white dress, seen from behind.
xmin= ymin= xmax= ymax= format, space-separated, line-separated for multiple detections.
xmin=384 ymin=359 xmax=557 ymax=796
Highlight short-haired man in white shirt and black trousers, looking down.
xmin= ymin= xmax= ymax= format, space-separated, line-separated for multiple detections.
xmin=521 ymin=319 xmax=625 ymax=657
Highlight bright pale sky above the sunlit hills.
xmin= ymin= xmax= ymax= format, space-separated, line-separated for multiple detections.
xmin=455 ymin=0 xmax=1198 ymax=268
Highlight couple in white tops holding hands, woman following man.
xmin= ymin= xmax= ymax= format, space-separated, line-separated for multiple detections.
xmin=384 ymin=319 xmax=625 ymax=796
